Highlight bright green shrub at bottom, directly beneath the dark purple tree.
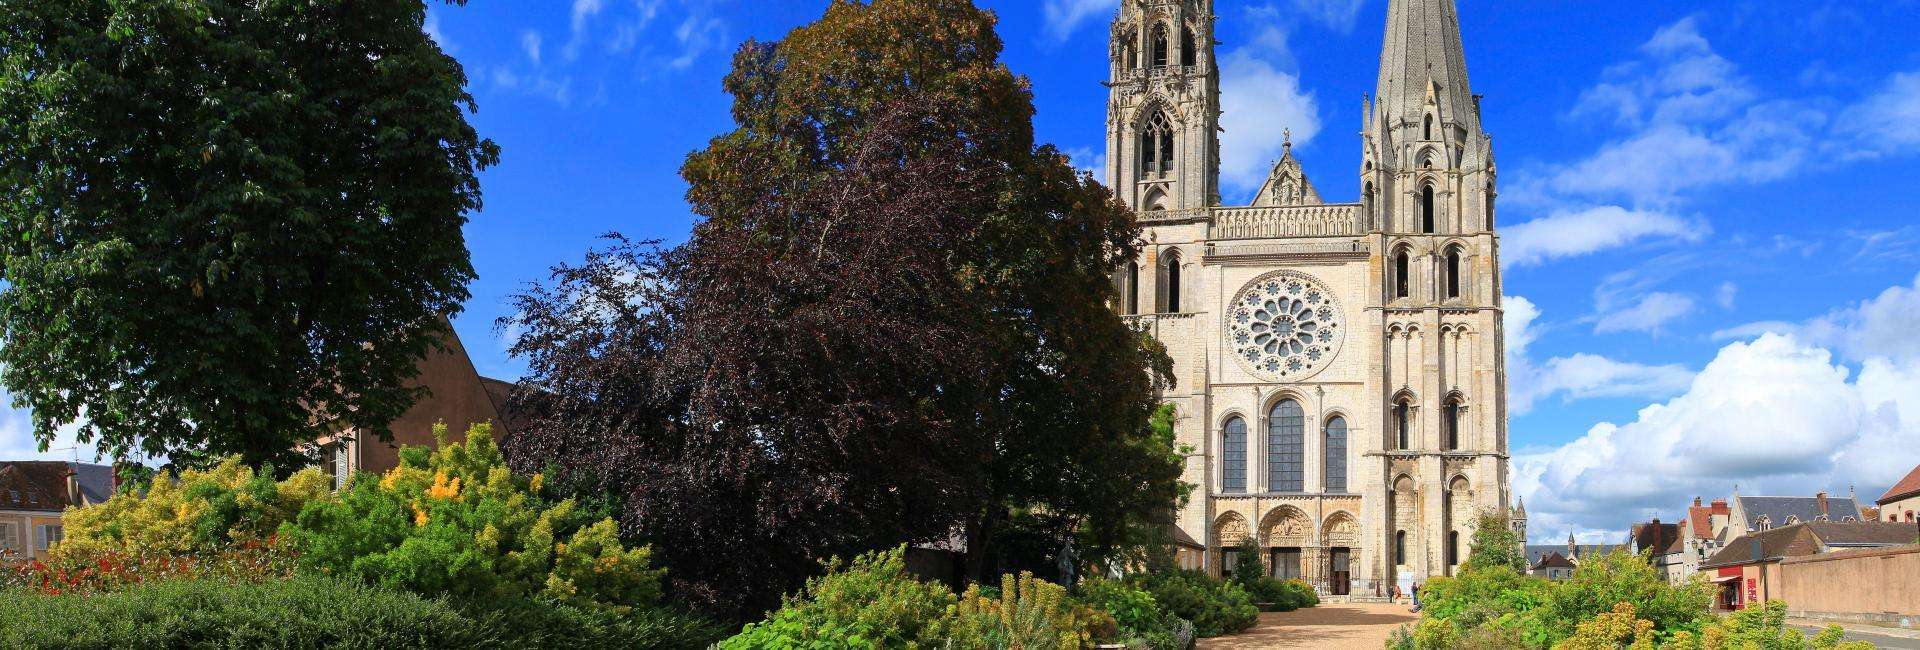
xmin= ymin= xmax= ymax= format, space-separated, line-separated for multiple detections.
xmin=720 ymin=546 xmax=972 ymax=650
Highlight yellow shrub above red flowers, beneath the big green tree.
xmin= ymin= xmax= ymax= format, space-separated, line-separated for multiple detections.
xmin=60 ymin=456 xmax=332 ymax=554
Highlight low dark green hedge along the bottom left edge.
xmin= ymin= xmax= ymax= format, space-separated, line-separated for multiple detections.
xmin=0 ymin=575 xmax=726 ymax=650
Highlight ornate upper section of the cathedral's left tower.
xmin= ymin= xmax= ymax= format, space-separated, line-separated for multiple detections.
xmin=1106 ymin=0 xmax=1219 ymax=213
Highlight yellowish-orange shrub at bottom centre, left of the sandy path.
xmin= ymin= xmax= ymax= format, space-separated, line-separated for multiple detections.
xmin=943 ymin=573 xmax=1119 ymax=650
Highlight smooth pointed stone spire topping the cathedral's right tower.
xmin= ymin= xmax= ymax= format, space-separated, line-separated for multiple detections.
xmin=1379 ymin=0 xmax=1480 ymax=132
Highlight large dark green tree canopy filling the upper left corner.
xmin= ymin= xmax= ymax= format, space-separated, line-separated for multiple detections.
xmin=0 ymin=0 xmax=499 ymax=464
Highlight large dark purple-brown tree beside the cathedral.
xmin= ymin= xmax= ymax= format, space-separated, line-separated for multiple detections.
xmin=507 ymin=0 xmax=1181 ymax=614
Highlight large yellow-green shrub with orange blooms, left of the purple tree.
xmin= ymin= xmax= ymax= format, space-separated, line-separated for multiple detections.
xmin=282 ymin=424 xmax=662 ymax=606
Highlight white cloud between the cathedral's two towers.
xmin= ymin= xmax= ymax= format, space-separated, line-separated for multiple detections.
xmin=1219 ymin=22 xmax=1321 ymax=192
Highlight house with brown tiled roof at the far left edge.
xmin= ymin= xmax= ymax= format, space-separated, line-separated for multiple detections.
xmin=0 ymin=460 xmax=113 ymax=558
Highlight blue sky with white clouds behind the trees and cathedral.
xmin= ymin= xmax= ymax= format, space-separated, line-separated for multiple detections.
xmin=0 ymin=0 xmax=1920 ymax=539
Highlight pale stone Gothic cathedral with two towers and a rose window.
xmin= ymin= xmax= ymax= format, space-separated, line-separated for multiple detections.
xmin=1104 ymin=0 xmax=1524 ymax=596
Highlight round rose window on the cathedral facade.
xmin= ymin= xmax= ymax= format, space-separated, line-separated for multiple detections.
xmin=1227 ymin=270 xmax=1346 ymax=382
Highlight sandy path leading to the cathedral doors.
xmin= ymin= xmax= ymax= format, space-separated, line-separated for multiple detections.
xmin=1200 ymin=602 xmax=1419 ymax=650
